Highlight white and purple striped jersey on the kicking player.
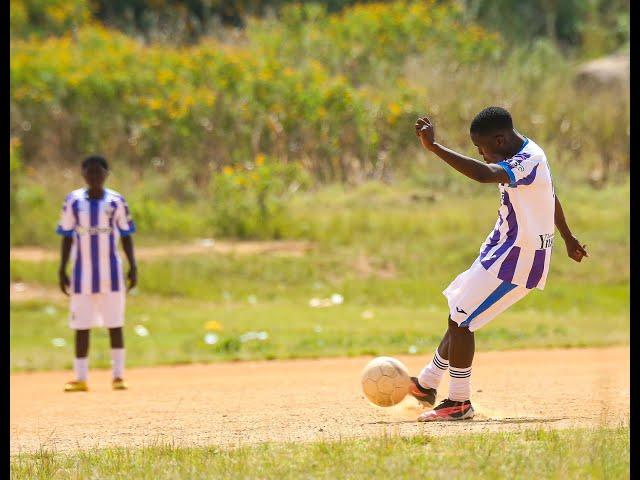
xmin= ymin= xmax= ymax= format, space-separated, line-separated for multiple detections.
xmin=478 ymin=139 xmax=555 ymax=290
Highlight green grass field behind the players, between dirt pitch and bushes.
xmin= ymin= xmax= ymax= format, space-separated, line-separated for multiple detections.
xmin=11 ymin=180 xmax=630 ymax=371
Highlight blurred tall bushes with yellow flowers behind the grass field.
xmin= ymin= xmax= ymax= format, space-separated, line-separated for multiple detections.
xmin=10 ymin=0 xmax=629 ymax=244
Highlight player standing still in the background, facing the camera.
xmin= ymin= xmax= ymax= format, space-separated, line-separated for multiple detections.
xmin=56 ymin=156 xmax=138 ymax=392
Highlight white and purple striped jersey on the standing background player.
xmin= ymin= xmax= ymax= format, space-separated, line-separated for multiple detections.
xmin=56 ymin=188 xmax=135 ymax=294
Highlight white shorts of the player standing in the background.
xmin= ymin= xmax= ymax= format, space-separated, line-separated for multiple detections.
xmin=69 ymin=292 xmax=125 ymax=330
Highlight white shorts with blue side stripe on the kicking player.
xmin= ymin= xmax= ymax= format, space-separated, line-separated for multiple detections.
xmin=442 ymin=260 xmax=531 ymax=332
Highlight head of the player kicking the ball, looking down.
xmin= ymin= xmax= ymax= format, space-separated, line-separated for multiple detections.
xmin=469 ymin=107 xmax=514 ymax=163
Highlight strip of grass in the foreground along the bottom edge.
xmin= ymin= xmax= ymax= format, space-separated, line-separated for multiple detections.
xmin=11 ymin=425 xmax=630 ymax=480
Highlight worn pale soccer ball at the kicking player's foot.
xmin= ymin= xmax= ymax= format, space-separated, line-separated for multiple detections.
xmin=362 ymin=357 xmax=411 ymax=407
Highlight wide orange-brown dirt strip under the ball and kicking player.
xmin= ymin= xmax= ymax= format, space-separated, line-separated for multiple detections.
xmin=11 ymin=347 xmax=630 ymax=454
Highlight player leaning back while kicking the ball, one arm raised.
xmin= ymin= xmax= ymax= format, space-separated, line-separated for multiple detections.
xmin=409 ymin=107 xmax=588 ymax=422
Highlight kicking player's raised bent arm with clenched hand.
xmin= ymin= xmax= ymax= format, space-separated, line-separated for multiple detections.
xmin=416 ymin=117 xmax=510 ymax=183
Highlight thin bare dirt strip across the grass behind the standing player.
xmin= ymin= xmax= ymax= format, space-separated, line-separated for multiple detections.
xmin=9 ymin=239 xmax=313 ymax=262
